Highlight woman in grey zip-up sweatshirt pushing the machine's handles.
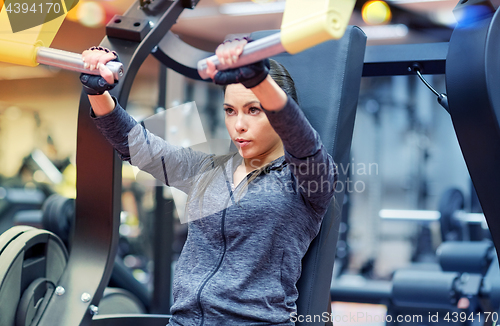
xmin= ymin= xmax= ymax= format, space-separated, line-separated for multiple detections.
xmin=82 ymin=40 xmax=336 ymax=326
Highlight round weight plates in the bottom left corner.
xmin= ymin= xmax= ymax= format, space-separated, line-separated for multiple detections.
xmin=0 ymin=226 xmax=68 ymax=326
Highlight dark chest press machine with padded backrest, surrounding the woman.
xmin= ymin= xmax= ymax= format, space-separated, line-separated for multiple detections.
xmin=0 ymin=0 xmax=500 ymax=326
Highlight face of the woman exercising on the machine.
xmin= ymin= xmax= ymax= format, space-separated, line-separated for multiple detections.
xmin=224 ymin=84 xmax=283 ymax=166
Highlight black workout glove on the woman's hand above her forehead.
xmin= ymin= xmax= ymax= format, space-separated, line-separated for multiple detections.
xmin=214 ymin=38 xmax=270 ymax=88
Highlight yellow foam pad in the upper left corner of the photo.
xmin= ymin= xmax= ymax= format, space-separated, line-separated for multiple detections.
xmin=0 ymin=0 xmax=67 ymax=67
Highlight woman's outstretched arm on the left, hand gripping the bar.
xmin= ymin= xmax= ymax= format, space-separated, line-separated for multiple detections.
xmin=82 ymin=51 xmax=210 ymax=193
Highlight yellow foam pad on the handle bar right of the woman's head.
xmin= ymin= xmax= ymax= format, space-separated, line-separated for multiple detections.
xmin=281 ymin=0 xmax=356 ymax=54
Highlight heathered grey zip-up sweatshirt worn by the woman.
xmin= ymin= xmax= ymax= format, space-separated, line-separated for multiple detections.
xmin=92 ymin=97 xmax=337 ymax=326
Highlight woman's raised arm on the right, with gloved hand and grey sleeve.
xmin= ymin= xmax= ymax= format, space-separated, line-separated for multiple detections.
xmin=207 ymin=40 xmax=337 ymax=215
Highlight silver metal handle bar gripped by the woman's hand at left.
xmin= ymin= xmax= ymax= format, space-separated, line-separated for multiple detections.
xmin=36 ymin=47 xmax=123 ymax=80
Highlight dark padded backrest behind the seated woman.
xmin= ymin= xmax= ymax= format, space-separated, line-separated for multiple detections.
xmin=251 ymin=26 xmax=366 ymax=326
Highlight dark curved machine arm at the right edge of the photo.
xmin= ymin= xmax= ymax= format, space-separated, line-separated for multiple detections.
xmin=446 ymin=1 xmax=500 ymax=255
